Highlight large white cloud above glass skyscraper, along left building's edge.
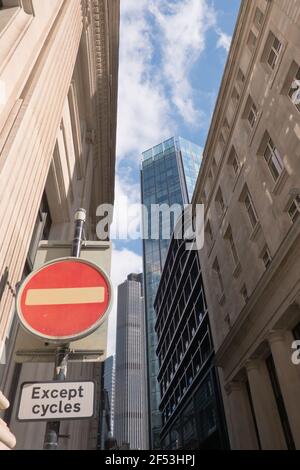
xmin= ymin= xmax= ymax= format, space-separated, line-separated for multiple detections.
xmin=117 ymin=0 xmax=174 ymax=160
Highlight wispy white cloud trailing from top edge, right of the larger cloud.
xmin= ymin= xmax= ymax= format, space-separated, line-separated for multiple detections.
xmin=150 ymin=0 xmax=216 ymax=125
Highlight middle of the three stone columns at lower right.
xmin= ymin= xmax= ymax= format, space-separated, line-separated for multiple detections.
xmin=246 ymin=360 xmax=287 ymax=449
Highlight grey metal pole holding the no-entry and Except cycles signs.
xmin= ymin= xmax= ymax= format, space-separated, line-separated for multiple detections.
xmin=44 ymin=209 xmax=86 ymax=450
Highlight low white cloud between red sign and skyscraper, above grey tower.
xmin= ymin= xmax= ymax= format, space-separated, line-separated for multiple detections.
xmin=107 ymin=248 xmax=142 ymax=356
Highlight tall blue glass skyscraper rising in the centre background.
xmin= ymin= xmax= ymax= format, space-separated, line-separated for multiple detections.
xmin=141 ymin=137 xmax=201 ymax=449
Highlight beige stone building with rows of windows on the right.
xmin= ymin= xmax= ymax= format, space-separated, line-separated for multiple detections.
xmin=194 ymin=0 xmax=300 ymax=449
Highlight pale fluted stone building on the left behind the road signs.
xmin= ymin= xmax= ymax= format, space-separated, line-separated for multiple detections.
xmin=0 ymin=0 xmax=120 ymax=449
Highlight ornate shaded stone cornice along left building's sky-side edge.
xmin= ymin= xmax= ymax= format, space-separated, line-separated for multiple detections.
xmin=88 ymin=0 xmax=120 ymax=211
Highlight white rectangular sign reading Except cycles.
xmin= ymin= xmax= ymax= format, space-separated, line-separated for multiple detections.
xmin=17 ymin=381 xmax=95 ymax=421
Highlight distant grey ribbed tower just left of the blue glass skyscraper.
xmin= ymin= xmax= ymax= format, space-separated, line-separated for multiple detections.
xmin=114 ymin=274 xmax=148 ymax=450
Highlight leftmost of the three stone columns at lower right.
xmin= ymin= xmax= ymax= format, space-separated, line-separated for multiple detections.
xmin=225 ymin=382 xmax=258 ymax=450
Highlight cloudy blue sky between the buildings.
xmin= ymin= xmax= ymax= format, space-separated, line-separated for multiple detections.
xmin=108 ymin=0 xmax=240 ymax=352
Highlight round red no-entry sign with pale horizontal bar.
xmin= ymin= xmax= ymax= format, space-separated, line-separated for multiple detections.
xmin=17 ymin=258 xmax=112 ymax=342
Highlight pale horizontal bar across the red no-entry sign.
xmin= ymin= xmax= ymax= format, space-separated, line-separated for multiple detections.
xmin=25 ymin=287 xmax=104 ymax=306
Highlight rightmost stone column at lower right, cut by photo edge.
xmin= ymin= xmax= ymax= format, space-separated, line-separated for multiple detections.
xmin=268 ymin=330 xmax=300 ymax=449
